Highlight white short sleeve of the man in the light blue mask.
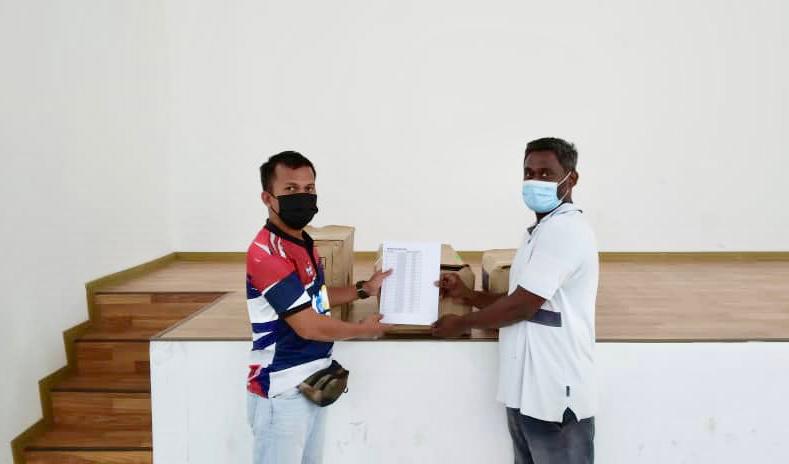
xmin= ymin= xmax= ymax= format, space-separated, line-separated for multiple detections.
xmin=517 ymin=221 xmax=581 ymax=300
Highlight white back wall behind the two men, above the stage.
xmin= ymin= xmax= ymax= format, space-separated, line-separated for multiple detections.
xmin=167 ymin=0 xmax=789 ymax=251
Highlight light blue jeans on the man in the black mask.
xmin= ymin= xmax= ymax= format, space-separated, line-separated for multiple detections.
xmin=247 ymin=388 xmax=326 ymax=464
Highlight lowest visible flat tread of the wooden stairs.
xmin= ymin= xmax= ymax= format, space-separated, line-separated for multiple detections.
xmin=25 ymin=427 xmax=151 ymax=451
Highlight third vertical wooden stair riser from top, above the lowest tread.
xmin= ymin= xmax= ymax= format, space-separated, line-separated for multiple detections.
xmin=52 ymin=392 xmax=151 ymax=430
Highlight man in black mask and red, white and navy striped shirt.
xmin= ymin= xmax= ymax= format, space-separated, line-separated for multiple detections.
xmin=247 ymin=151 xmax=390 ymax=464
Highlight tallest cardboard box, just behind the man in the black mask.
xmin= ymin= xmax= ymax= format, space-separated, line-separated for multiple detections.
xmin=304 ymin=226 xmax=355 ymax=320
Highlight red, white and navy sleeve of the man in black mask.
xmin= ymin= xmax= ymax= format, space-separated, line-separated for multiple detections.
xmin=247 ymin=246 xmax=312 ymax=317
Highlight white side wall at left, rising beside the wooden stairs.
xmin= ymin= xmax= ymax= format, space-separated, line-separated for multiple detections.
xmin=0 ymin=0 xmax=172 ymax=464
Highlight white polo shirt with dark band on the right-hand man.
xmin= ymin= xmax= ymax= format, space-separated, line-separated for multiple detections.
xmin=498 ymin=203 xmax=599 ymax=422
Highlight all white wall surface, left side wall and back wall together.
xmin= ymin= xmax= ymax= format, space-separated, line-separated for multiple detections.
xmin=0 ymin=0 xmax=789 ymax=463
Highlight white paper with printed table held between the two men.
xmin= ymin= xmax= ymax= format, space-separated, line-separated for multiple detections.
xmin=380 ymin=242 xmax=441 ymax=325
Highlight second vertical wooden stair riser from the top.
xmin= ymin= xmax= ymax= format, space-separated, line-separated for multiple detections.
xmin=74 ymin=339 xmax=151 ymax=375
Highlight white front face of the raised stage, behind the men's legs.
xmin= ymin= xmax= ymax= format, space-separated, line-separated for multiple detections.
xmin=151 ymin=341 xmax=789 ymax=464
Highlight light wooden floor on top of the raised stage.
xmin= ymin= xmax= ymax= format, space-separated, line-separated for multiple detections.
xmin=92 ymin=257 xmax=789 ymax=342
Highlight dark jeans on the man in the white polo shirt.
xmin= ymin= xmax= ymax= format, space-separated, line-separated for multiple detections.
xmin=507 ymin=408 xmax=594 ymax=464
